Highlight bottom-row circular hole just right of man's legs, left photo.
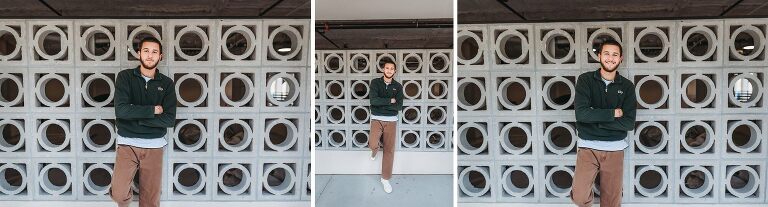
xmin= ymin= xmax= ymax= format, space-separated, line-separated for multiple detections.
xmin=173 ymin=163 xmax=206 ymax=195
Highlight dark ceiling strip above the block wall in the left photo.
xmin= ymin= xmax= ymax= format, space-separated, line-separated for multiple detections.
xmin=0 ymin=0 xmax=311 ymax=19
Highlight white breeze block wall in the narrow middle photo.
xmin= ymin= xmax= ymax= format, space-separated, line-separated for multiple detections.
xmin=314 ymin=49 xmax=453 ymax=152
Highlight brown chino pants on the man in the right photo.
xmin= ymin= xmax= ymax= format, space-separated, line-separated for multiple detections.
xmin=571 ymin=148 xmax=624 ymax=207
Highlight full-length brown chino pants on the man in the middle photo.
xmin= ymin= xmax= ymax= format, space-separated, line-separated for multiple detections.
xmin=368 ymin=120 xmax=397 ymax=180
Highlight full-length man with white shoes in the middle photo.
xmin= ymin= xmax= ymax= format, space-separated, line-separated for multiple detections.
xmin=368 ymin=61 xmax=403 ymax=193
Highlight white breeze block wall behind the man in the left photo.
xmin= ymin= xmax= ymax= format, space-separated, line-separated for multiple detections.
xmin=0 ymin=19 xmax=311 ymax=201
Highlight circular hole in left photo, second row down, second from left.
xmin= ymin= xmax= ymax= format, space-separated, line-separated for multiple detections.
xmin=36 ymin=73 xmax=69 ymax=107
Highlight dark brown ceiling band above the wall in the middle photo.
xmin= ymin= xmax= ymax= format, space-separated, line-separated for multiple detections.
xmin=315 ymin=19 xmax=453 ymax=50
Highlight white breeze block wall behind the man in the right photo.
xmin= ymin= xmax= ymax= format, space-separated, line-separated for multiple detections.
xmin=456 ymin=19 xmax=768 ymax=203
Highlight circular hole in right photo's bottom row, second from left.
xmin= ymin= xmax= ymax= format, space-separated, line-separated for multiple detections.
xmin=501 ymin=166 xmax=533 ymax=197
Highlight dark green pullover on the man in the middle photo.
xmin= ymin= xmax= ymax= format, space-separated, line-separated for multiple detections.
xmin=368 ymin=77 xmax=403 ymax=116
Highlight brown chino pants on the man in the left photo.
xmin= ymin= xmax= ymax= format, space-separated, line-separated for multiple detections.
xmin=110 ymin=145 xmax=163 ymax=207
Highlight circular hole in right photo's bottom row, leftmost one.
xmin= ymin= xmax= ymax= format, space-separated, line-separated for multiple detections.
xmin=459 ymin=166 xmax=491 ymax=197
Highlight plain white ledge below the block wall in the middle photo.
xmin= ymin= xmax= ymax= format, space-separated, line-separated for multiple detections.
xmin=314 ymin=150 xmax=454 ymax=174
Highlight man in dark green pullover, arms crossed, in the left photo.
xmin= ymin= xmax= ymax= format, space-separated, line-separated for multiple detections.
xmin=110 ymin=37 xmax=176 ymax=207
